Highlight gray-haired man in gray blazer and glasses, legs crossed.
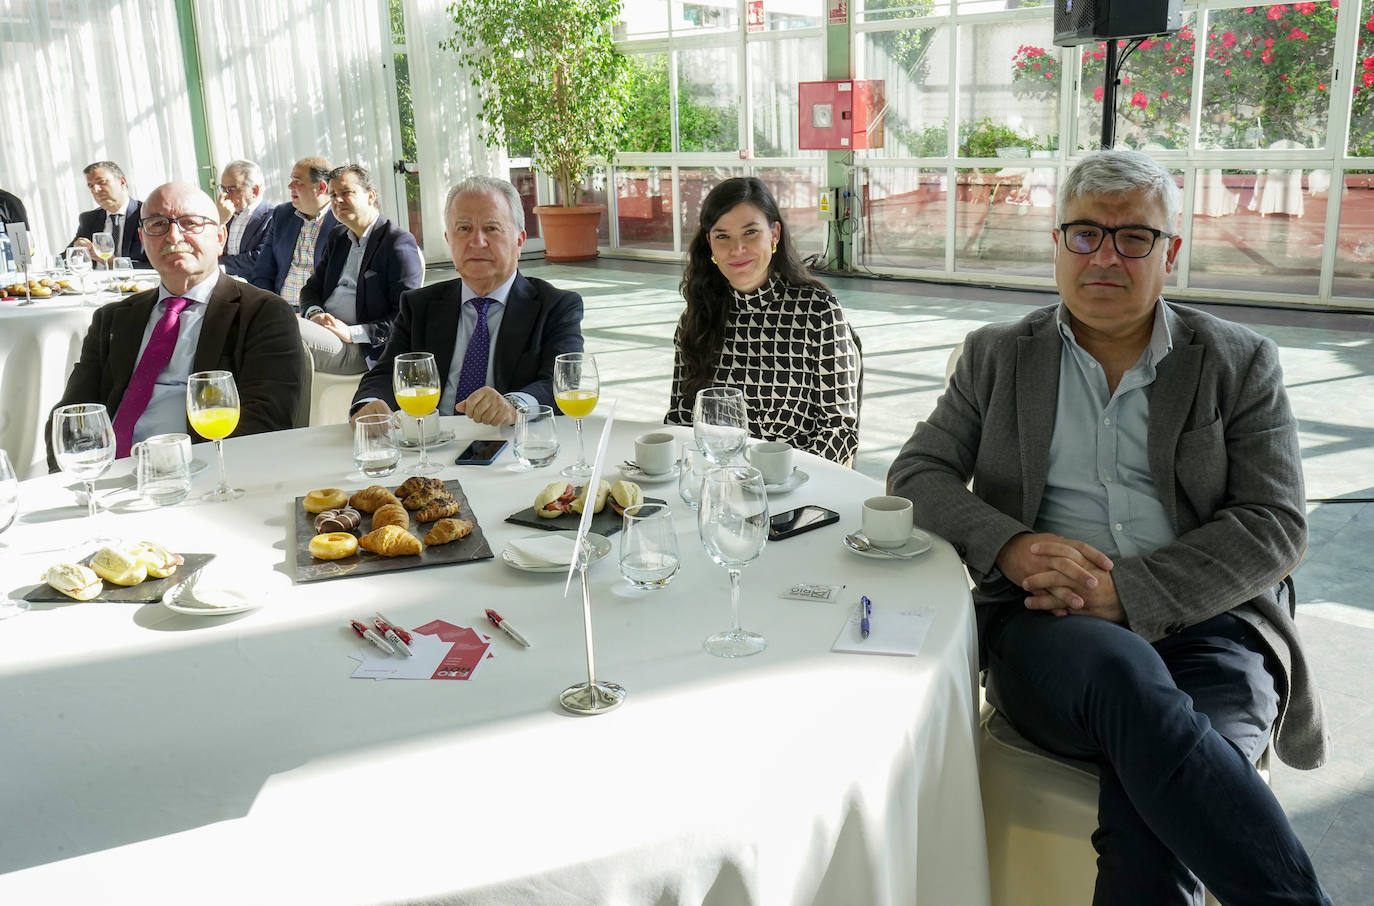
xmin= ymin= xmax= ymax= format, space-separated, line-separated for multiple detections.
xmin=888 ymin=151 xmax=1330 ymax=906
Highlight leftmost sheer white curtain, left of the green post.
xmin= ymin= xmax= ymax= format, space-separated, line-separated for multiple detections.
xmin=0 ymin=0 xmax=196 ymax=254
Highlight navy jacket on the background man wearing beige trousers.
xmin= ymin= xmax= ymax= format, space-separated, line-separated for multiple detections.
xmin=301 ymin=214 xmax=425 ymax=366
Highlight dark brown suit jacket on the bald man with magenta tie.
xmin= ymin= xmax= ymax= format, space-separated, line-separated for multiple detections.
xmin=44 ymin=275 xmax=304 ymax=472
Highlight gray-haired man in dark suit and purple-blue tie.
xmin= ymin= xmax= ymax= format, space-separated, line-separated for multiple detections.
xmin=353 ymin=176 xmax=583 ymax=425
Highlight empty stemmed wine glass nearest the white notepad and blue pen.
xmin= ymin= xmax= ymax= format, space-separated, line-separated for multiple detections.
xmin=697 ymin=466 xmax=768 ymax=657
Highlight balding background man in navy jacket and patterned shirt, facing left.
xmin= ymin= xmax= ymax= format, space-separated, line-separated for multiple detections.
xmin=249 ymin=157 xmax=338 ymax=308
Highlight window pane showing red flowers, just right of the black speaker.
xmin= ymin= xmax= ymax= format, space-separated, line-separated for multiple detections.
xmin=1200 ymin=3 xmax=1336 ymax=148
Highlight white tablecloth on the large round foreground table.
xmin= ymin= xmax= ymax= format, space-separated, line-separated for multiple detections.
xmin=0 ymin=415 xmax=988 ymax=906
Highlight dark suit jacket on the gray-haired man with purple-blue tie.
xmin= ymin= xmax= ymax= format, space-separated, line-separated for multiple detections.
xmin=353 ymin=274 xmax=583 ymax=415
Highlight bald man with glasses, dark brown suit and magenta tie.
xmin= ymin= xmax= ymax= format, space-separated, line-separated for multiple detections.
xmin=44 ymin=183 xmax=302 ymax=470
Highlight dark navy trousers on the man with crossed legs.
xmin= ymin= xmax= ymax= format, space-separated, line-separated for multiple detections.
xmin=987 ymin=608 xmax=1330 ymax=906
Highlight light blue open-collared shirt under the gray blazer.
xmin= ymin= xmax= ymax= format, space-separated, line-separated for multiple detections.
xmin=1035 ymin=302 xmax=1175 ymax=557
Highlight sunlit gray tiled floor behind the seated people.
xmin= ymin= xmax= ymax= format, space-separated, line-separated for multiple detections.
xmin=494 ymin=252 xmax=1374 ymax=906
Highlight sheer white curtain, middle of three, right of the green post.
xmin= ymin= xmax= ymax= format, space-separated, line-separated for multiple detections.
xmin=195 ymin=0 xmax=405 ymax=224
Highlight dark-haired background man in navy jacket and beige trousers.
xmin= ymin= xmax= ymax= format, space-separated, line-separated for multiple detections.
xmin=301 ymin=164 xmax=423 ymax=374
